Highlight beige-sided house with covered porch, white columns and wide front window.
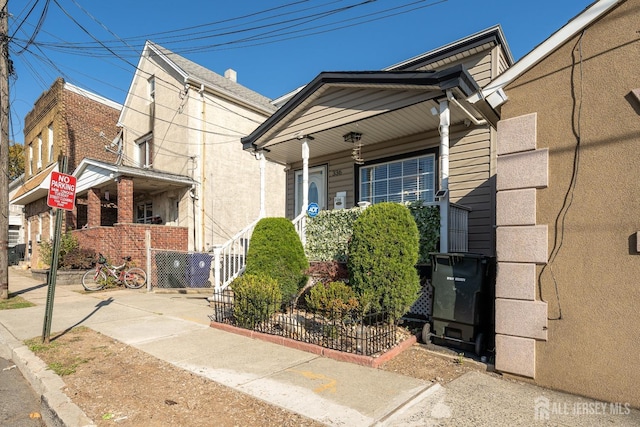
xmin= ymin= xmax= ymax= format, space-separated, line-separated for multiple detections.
xmin=212 ymin=26 xmax=513 ymax=287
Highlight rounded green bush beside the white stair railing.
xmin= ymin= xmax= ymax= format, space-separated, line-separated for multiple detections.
xmin=245 ymin=218 xmax=309 ymax=303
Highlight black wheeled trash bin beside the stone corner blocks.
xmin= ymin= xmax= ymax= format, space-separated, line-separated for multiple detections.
xmin=422 ymin=253 xmax=492 ymax=354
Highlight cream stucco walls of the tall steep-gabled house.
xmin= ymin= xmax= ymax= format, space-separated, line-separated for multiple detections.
xmin=122 ymin=52 xmax=285 ymax=250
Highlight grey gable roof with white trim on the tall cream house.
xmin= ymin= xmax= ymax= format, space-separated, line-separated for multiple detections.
xmin=118 ymin=40 xmax=276 ymax=123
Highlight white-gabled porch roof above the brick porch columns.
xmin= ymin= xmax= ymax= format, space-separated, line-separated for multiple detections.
xmin=73 ymin=158 xmax=196 ymax=196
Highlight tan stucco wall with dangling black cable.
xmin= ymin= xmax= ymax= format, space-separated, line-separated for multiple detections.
xmin=497 ymin=0 xmax=640 ymax=407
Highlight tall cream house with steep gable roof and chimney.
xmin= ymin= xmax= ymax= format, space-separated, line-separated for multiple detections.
xmin=77 ymin=41 xmax=285 ymax=258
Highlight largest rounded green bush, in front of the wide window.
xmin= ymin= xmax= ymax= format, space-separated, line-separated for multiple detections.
xmin=347 ymin=203 xmax=420 ymax=320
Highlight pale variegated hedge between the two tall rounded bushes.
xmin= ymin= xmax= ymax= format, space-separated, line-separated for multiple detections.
xmin=305 ymin=207 xmax=364 ymax=262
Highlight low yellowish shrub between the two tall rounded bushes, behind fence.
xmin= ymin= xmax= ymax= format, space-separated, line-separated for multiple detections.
xmin=305 ymin=282 xmax=360 ymax=318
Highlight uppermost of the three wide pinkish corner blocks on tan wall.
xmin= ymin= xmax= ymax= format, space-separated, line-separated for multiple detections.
xmin=496 ymin=148 xmax=549 ymax=191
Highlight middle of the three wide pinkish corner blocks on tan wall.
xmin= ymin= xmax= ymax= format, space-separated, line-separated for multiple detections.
xmin=496 ymin=225 xmax=548 ymax=264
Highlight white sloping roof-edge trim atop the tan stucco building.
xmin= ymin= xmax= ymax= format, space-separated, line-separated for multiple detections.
xmin=468 ymin=0 xmax=626 ymax=108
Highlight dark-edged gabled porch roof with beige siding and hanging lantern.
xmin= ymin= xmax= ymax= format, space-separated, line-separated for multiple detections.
xmin=242 ymin=65 xmax=498 ymax=164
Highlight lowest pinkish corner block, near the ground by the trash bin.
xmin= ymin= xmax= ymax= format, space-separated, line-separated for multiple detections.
xmin=496 ymin=335 xmax=536 ymax=378
